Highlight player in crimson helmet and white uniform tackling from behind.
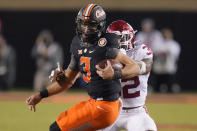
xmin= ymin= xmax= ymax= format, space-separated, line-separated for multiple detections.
xmin=98 ymin=20 xmax=157 ymax=131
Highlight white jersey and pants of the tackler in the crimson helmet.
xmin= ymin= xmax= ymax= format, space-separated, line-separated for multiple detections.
xmin=99 ymin=43 xmax=157 ymax=131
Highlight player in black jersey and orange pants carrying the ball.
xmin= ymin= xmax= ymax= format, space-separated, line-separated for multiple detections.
xmin=26 ymin=4 xmax=140 ymax=131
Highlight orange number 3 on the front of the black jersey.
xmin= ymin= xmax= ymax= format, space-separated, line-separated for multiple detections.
xmin=80 ymin=57 xmax=91 ymax=83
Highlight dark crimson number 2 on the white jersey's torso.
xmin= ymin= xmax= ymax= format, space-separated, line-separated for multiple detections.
xmin=121 ymin=76 xmax=140 ymax=98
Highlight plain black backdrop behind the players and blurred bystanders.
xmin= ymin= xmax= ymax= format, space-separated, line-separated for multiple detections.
xmin=0 ymin=10 xmax=197 ymax=90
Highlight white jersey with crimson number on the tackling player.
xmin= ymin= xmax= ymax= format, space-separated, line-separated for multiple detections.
xmin=121 ymin=44 xmax=153 ymax=107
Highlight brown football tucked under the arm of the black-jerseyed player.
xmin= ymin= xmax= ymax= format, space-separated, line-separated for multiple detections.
xmin=98 ymin=59 xmax=124 ymax=70
